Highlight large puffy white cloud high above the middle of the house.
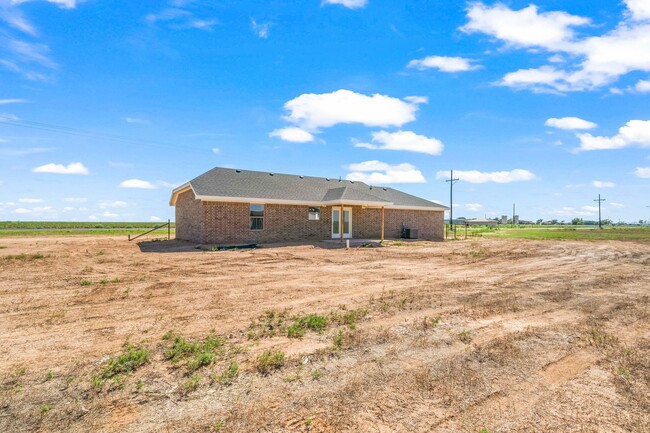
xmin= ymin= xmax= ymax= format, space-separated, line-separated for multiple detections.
xmin=284 ymin=89 xmax=422 ymax=131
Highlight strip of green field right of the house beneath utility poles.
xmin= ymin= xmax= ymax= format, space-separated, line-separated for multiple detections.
xmin=456 ymin=225 xmax=650 ymax=241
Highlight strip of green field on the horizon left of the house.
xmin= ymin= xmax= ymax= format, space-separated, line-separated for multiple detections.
xmin=0 ymin=221 xmax=174 ymax=237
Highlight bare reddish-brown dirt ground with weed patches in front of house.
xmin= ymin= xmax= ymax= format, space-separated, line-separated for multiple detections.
xmin=0 ymin=236 xmax=650 ymax=433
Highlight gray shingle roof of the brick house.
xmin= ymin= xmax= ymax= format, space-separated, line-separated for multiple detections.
xmin=172 ymin=167 xmax=447 ymax=210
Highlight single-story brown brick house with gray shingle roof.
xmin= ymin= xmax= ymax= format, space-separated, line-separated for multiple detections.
xmin=169 ymin=167 xmax=448 ymax=244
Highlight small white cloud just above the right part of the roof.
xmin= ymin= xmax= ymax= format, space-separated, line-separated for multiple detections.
xmin=345 ymin=160 xmax=426 ymax=185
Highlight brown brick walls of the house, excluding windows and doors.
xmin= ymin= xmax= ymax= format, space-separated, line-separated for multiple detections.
xmin=176 ymin=197 xmax=444 ymax=244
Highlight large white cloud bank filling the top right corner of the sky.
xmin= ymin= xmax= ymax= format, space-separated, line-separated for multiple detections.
xmin=462 ymin=1 xmax=650 ymax=92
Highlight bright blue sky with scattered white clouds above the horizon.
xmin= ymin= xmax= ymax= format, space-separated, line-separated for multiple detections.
xmin=0 ymin=0 xmax=650 ymax=221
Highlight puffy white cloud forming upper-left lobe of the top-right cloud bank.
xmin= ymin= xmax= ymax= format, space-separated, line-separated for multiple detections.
xmin=461 ymin=2 xmax=590 ymax=49
